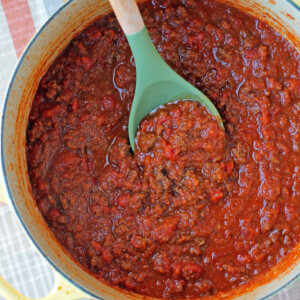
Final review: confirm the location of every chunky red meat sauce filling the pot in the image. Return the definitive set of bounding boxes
[26,0,300,298]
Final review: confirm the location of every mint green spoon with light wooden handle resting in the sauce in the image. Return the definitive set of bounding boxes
[109,0,224,150]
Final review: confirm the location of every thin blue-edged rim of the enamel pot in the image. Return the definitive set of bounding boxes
[0,0,300,300]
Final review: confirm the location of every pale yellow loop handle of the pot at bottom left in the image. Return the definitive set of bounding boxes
[0,270,91,300]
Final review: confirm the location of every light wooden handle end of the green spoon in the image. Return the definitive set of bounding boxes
[109,0,145,35]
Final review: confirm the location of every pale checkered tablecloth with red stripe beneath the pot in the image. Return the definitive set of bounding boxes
[0,0,300,300]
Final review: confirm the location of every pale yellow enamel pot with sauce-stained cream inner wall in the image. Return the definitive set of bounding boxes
[0,0,300,299]
